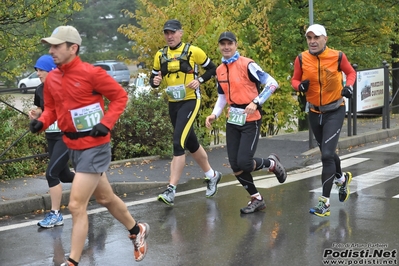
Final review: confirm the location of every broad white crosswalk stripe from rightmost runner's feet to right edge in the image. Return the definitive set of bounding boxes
[309,163,399,194]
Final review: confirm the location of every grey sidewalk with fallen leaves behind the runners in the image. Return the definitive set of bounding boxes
[0,115,399,217]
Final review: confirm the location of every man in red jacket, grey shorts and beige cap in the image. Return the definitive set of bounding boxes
[30,26,150,266]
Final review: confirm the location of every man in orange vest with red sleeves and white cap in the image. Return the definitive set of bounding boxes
[291,24,356,217]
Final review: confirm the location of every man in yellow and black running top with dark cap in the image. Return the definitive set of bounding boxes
[150,19,222,206]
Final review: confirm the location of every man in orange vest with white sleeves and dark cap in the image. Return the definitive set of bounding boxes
[205,31,287,214]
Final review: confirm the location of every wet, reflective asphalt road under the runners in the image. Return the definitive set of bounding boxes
[0,142,399,266]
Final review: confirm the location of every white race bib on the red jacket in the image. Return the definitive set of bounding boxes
[70,103,104,132]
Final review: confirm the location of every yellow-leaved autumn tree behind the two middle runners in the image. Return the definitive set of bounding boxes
[120,0,297,135]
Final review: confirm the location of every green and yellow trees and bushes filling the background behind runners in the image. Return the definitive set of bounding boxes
[0,0,399,178]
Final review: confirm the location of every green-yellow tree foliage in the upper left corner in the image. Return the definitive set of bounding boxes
[0,0,82,84]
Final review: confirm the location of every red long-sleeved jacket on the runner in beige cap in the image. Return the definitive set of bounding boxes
[38,56,128,150]
